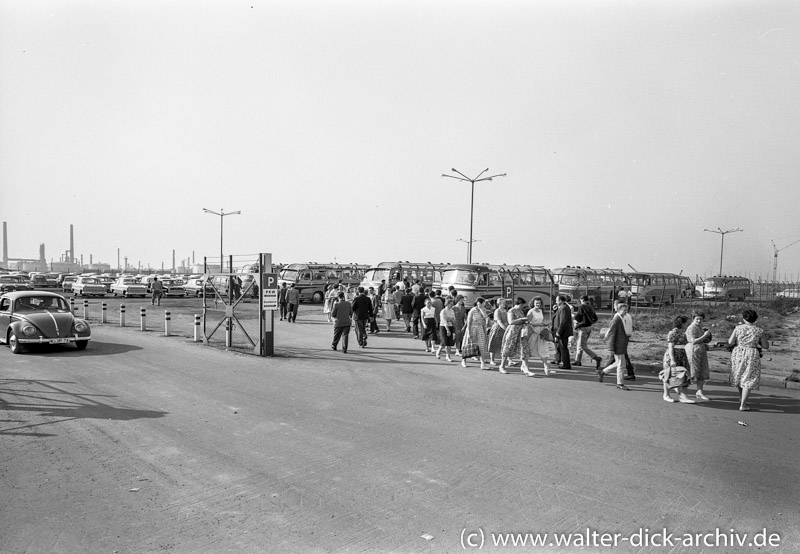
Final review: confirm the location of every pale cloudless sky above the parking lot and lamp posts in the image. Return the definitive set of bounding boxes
[0,0,800,280]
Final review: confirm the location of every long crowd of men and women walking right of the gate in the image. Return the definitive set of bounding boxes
[323,282,768,411]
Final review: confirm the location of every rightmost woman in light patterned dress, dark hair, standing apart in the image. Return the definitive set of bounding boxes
[728,309,769,412]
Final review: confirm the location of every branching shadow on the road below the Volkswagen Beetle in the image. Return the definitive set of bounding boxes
[0,379,169,437]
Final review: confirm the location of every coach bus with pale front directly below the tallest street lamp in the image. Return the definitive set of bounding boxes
[434,264,557,309]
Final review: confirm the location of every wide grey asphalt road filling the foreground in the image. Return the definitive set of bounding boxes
[0,305,800,553]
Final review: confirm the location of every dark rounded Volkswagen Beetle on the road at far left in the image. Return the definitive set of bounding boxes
[0,291,92,354]
